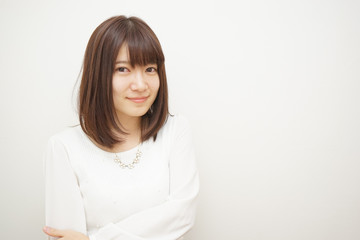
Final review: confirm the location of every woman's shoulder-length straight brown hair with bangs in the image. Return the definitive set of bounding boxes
[78,16,169,148]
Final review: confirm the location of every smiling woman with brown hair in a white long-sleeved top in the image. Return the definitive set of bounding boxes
[43,16,198,240]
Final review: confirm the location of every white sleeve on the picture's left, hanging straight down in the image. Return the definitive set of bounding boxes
[44,137,86,239]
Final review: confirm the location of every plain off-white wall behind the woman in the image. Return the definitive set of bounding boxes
[0,0,360,240]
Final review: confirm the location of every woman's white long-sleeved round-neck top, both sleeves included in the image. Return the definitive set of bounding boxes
[45,116,199,240]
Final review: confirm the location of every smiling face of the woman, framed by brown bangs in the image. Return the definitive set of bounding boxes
[112,44,160,121]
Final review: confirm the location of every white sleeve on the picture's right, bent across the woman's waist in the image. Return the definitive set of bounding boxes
[90,119,199,240]
